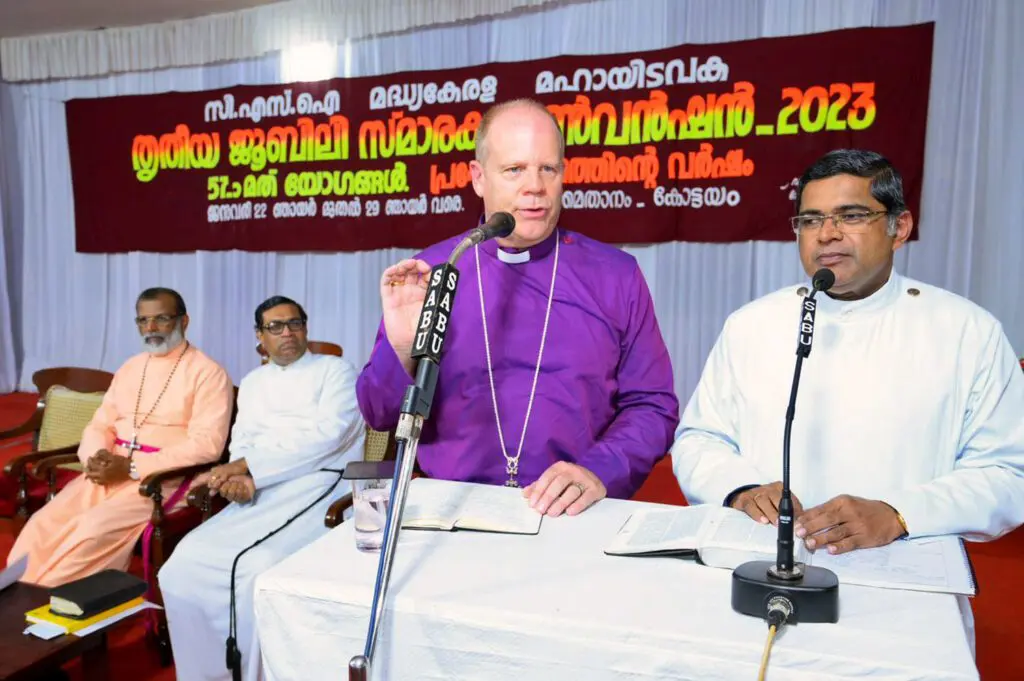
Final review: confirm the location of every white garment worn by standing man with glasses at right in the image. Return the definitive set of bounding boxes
[672,272,1024,539]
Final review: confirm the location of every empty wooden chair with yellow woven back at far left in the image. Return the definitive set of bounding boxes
[0,367,114,534]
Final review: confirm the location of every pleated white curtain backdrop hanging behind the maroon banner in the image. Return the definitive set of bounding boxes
[0,0,1024,403]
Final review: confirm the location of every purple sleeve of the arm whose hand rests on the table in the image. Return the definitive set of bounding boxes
[577,266,679,499]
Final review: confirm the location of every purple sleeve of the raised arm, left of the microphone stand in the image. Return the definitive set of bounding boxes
[355,321,413,430]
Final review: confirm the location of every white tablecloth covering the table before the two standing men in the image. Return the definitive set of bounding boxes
[255,493,978,681]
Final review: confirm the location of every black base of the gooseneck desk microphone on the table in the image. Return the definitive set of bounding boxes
[732,560,839,624]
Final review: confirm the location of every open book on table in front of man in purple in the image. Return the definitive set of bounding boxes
[401,477,544,535]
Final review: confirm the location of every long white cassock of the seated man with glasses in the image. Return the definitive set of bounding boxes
[159,352,365,681]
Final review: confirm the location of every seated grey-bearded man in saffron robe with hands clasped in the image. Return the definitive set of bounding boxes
[7,288,233,587]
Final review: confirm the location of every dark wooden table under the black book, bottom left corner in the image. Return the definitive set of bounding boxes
[0,582,110,681]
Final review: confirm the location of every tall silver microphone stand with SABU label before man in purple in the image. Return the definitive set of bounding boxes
[348,229,495,681]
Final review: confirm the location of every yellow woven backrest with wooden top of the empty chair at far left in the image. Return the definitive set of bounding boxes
[32,367,114,450]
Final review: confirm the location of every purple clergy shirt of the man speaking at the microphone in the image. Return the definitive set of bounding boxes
[356,228,679,498]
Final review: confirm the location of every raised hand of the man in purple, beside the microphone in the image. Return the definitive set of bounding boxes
[381,260,430,375]
